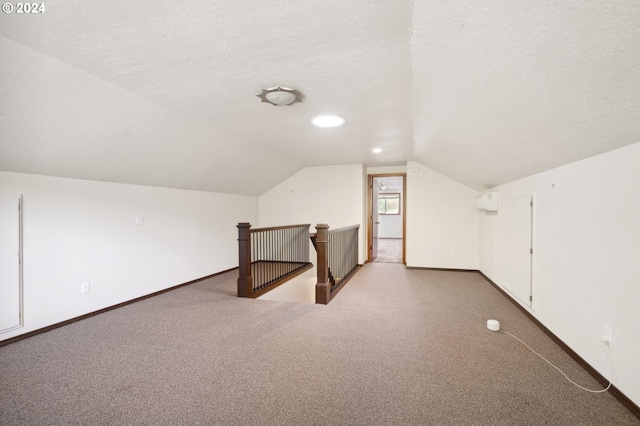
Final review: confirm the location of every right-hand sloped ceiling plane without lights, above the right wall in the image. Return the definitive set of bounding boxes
[412,0,640,188]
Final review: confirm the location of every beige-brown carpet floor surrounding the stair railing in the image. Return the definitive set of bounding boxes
[0,263,640,425]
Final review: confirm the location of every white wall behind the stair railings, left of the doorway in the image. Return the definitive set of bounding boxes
[252,164,367,263]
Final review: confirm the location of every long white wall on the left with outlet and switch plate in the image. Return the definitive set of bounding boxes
[0,172,258,340]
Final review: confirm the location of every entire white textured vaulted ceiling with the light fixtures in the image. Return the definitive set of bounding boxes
[0,0,640,195]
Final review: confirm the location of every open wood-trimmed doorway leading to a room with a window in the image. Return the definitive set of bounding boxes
[367,173,407,264]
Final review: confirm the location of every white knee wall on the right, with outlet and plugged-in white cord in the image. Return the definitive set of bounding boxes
[480,143,640,405]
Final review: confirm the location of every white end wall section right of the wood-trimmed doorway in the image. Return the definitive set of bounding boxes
[406,161,479,269]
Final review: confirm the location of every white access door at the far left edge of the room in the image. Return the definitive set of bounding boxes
[0,194,22,332]
